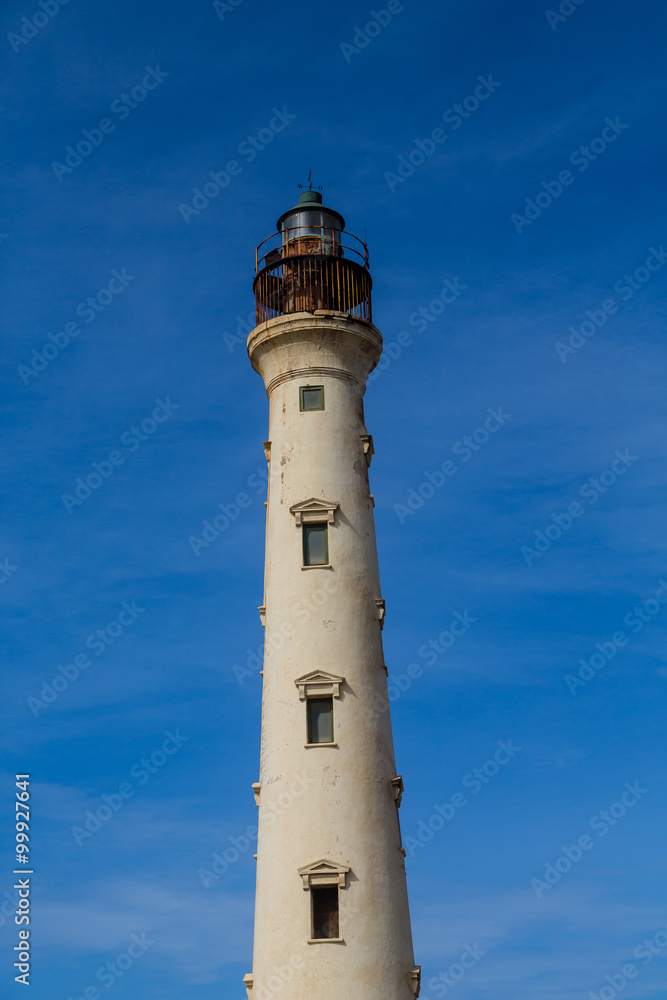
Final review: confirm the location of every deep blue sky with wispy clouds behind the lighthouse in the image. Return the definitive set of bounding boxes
[0,0,667,1000]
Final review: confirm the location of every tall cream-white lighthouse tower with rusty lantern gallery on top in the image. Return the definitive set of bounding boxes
[244,186,420,1000]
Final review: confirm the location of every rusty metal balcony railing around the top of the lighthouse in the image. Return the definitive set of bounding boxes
[253,226,373,324]
